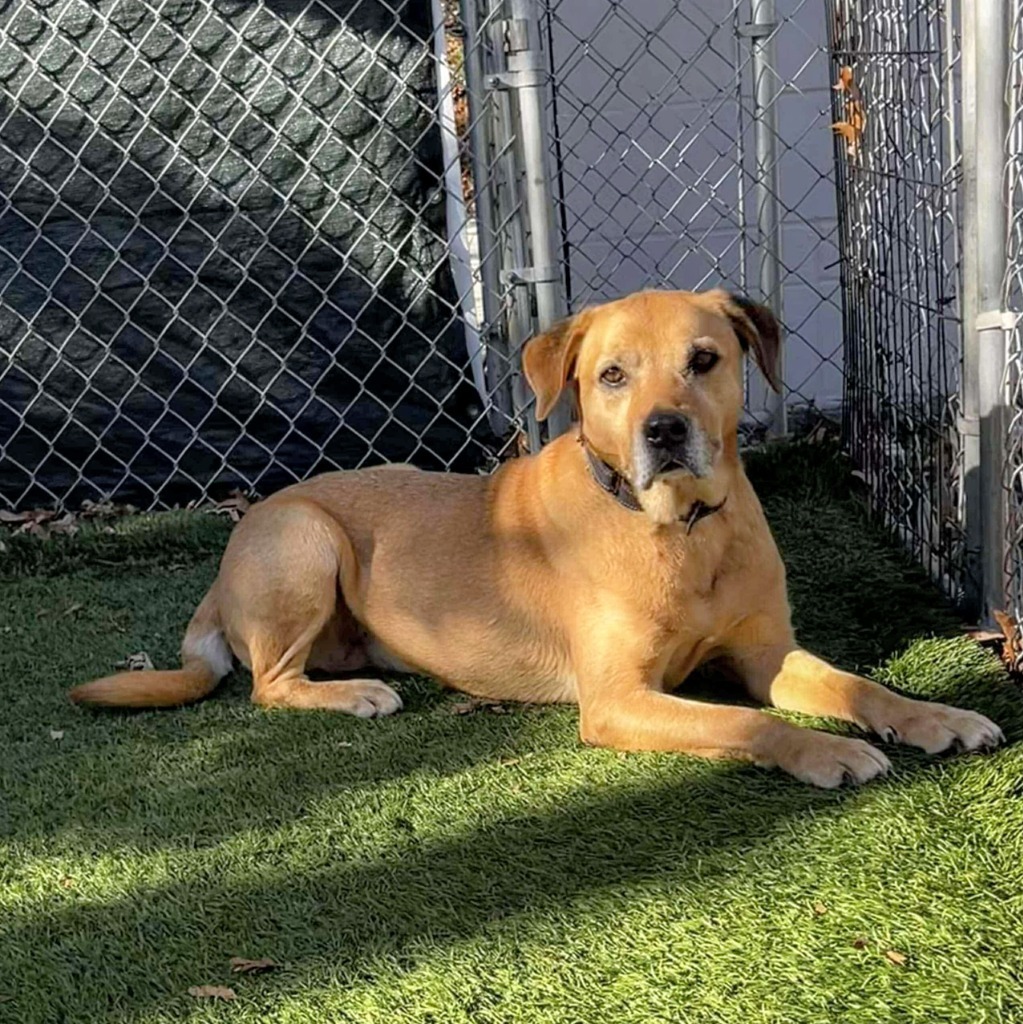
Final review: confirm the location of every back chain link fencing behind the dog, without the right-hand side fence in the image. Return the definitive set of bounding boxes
[0,0,842,507]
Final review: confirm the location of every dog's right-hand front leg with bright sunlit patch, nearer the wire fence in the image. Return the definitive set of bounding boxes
[729,641,1005,754]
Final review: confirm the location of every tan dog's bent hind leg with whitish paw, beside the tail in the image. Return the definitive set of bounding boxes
[217,499,401,718]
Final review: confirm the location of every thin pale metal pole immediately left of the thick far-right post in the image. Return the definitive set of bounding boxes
[948,0,984,622]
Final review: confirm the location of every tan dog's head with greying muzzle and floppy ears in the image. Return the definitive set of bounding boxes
[523,291,779,522]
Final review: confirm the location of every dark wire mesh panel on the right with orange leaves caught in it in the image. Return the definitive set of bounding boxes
[827,0,965,598]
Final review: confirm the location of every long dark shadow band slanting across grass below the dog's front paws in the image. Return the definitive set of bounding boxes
[0,745,925,1024]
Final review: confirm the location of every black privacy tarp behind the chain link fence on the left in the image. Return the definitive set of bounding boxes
[0,0,492,507]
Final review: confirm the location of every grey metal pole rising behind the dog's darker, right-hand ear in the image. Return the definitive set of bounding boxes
[747,0,787,437]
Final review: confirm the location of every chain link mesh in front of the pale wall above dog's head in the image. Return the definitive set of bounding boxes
[544,0,843,429]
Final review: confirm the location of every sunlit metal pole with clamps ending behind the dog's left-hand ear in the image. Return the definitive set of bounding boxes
[508,0,571,436]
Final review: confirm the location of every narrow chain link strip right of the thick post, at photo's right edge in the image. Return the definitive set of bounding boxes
[1005,0,1023,670]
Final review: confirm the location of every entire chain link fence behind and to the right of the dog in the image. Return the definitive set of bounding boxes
[0,0,1023,643]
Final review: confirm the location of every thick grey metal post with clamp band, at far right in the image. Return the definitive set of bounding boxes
[964,0,1009,622]
